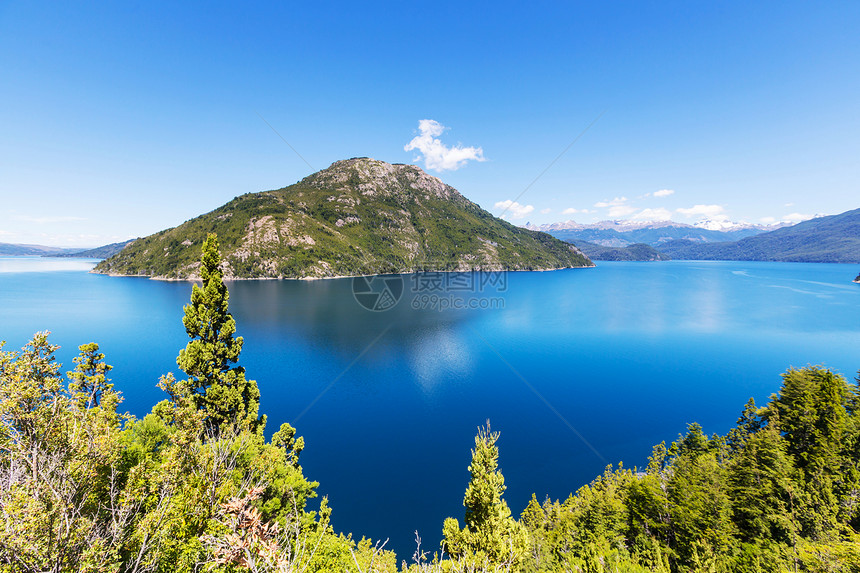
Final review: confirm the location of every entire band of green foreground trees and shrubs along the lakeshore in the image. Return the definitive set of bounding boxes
[0,237,860,573]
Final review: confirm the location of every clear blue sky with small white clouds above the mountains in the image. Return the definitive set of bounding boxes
[0,1,860,246]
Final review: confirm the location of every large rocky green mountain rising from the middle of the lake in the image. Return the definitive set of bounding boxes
[95,158,592,279]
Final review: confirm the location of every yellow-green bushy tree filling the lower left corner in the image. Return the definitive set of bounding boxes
[0,332,129,573]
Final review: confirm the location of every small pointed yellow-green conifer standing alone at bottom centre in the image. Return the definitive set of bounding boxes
[442,420,526,565]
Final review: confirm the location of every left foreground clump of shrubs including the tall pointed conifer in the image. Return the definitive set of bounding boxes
[0,237,394,573]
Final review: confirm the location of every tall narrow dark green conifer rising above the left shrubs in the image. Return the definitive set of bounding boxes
[176,233,265,429]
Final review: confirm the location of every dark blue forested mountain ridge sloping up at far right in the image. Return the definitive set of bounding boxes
[660,209,860,263]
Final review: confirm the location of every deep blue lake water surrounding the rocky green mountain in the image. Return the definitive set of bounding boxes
[0,258,860,559]
